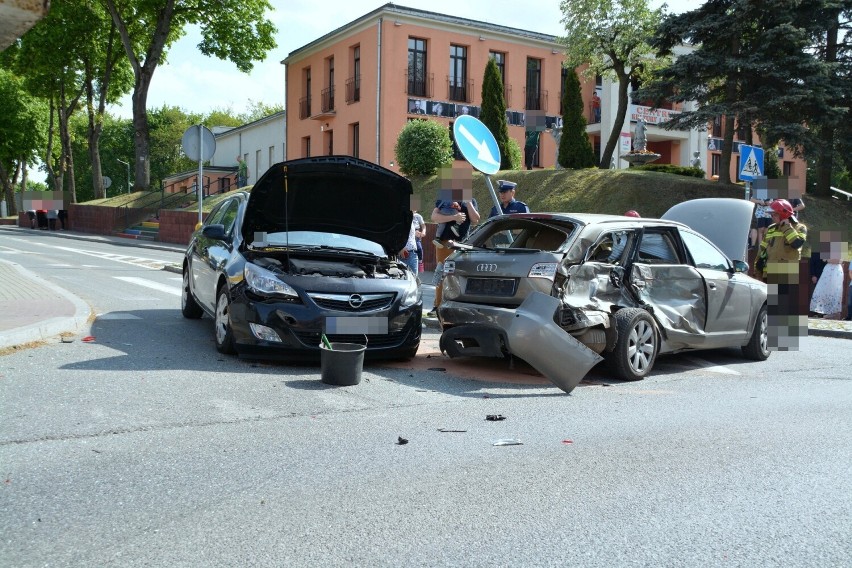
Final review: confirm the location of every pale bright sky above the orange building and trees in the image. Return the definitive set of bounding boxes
[109,0,703,118]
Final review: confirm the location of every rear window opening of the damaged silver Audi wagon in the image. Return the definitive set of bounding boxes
[466,218,575,251]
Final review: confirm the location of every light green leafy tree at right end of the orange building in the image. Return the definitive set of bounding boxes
[560,0,667,168]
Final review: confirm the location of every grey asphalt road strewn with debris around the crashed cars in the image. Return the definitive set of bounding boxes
[0,232,852,567]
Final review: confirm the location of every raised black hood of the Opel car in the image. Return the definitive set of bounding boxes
[242,156,413,255]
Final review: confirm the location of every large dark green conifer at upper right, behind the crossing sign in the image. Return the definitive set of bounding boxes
[639,0,842,189]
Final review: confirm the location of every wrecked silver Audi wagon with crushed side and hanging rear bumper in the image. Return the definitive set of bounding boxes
[438,199,769,392]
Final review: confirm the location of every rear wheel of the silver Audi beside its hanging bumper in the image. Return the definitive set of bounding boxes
[607,308,660,381]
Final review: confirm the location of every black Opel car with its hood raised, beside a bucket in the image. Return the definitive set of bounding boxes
[181,156,423,359]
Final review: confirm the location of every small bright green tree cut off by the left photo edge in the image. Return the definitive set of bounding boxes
[0,68,48,214]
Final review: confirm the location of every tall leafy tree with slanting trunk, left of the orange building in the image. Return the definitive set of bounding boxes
[104,0,277,189]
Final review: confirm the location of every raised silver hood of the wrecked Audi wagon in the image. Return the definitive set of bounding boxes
[662,197,754,260]
